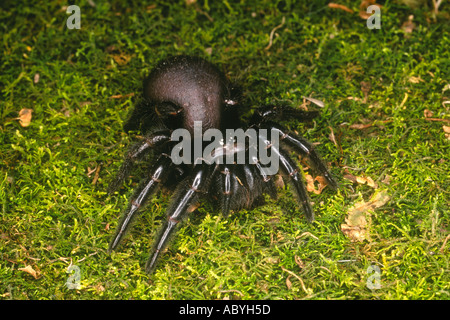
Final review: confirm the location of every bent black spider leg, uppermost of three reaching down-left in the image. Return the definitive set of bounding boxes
[108,130,170,194]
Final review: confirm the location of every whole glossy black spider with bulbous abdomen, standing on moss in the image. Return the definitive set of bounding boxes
[109,56,337,273]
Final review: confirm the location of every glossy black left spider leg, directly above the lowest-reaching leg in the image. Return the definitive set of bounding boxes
[108,154,172,252]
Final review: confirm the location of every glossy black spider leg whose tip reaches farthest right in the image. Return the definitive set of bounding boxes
[267,123,338,190]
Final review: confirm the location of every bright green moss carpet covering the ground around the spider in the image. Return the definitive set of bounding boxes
[0,1,450,299]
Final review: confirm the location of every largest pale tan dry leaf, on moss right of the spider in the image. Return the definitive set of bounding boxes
[341,190,390,242]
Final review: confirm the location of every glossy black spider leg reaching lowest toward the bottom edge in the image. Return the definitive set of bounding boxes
[145,165,212,273]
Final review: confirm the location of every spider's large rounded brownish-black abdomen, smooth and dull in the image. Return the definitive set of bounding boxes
[144,56,228,134]
